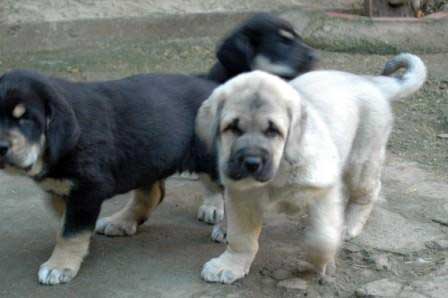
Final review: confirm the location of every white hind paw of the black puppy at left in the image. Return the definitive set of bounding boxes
[95,216,137,237]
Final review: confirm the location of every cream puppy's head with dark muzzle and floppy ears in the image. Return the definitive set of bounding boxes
[196,71,301,189]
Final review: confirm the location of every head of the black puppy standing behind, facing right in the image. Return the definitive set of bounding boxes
[217,13,316,79]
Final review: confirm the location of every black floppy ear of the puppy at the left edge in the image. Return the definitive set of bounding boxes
[43,86,81,164]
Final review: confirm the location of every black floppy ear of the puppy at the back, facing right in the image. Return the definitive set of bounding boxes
[216,32,255,76]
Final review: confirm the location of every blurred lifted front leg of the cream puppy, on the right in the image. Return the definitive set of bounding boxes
[305,185,343,276]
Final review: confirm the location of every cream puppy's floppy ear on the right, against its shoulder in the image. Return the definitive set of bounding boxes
[284,90,307,163]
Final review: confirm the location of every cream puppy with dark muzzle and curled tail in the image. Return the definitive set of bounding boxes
[196,54,426,283]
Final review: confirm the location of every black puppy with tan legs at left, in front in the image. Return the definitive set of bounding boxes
[0,12,316,284]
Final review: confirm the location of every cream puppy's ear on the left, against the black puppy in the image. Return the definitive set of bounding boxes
[196,87,225,150]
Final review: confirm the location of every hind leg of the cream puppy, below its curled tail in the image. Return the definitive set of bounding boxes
[344,147,386,240]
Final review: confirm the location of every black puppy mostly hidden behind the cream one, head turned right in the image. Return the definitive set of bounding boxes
[197,13,316,224]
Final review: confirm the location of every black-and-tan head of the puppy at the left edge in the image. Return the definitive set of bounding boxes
[0,70,79,176]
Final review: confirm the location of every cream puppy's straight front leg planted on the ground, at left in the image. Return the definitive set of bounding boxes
[201,191,263,284]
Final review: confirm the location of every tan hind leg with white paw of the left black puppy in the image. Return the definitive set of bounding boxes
[96,181,165,236]
